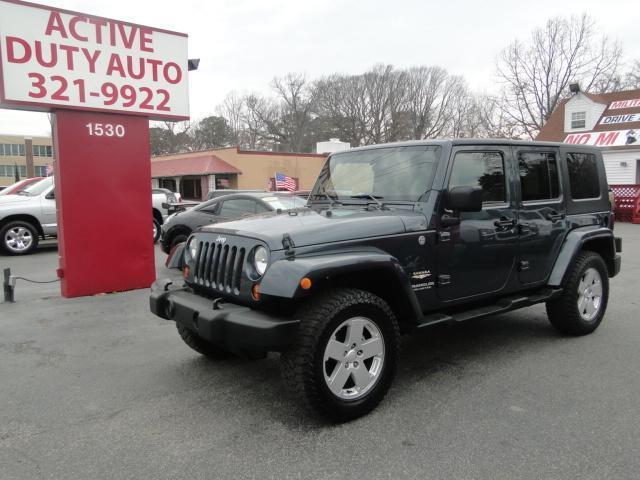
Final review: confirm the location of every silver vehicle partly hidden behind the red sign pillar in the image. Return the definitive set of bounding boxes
[0,177,168,255]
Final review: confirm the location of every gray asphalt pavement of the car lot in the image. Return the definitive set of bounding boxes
[0,223,640,480]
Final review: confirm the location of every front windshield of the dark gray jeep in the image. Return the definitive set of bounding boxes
[312,145,442,202]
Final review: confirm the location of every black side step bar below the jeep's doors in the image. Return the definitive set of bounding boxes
[416,288,562,328]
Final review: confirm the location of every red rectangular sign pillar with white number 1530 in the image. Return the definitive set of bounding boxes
[54,110,155,297]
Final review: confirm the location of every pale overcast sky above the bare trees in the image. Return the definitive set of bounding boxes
[0,0,640,135]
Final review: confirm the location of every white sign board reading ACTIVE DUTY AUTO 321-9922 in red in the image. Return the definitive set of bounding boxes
[0,0,189,120]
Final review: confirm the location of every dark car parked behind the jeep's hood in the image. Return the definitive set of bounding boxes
[160,192,306,253]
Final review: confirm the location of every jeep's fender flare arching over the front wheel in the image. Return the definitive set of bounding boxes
[260,249,422,318]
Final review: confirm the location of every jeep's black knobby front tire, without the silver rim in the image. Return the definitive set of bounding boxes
[281,288,400,422]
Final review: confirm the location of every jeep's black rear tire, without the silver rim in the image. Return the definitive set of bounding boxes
[547,250,609,336]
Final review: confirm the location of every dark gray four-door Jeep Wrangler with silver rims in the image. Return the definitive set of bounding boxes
[150,140,621,421]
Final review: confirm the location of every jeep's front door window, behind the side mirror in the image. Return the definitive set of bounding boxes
[449,152,506,202]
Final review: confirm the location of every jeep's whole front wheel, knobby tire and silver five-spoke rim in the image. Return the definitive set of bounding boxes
[281,289,400,422]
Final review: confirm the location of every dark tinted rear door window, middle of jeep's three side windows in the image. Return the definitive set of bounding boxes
[518,152,559,201]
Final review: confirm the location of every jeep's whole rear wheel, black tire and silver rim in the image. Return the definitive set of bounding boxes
[547,251,609,335]
